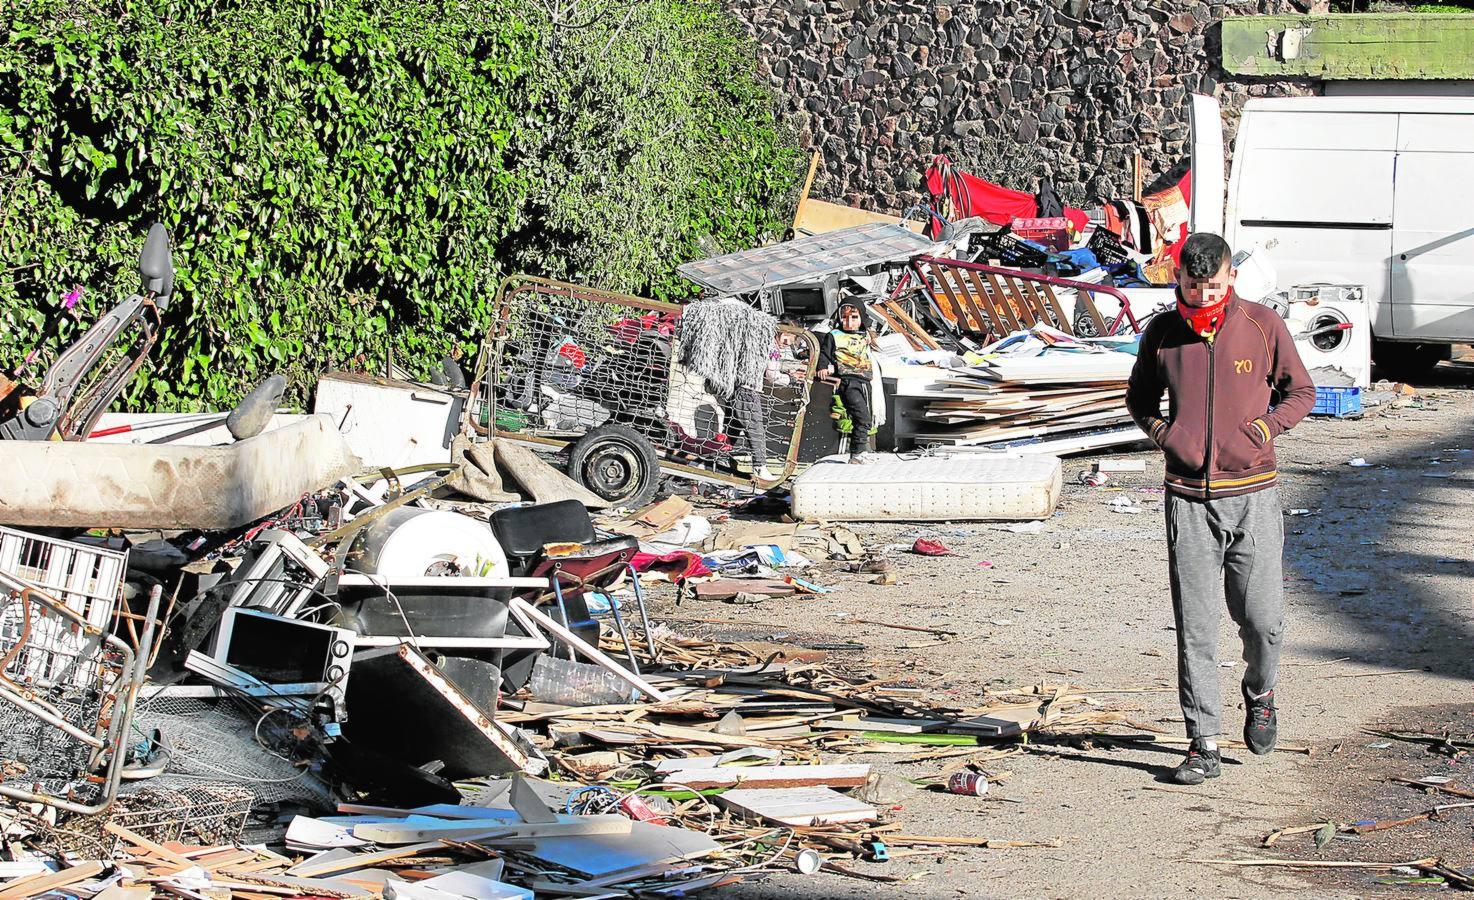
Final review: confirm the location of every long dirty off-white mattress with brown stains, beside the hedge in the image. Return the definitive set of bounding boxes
[0,415,361,530]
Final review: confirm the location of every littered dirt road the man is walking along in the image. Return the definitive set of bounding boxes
[662,365,1474,897]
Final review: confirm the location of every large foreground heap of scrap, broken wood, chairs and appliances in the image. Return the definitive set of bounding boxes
[0,471,1149,900]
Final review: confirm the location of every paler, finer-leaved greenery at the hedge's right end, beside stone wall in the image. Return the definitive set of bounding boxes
[509,0,803,299]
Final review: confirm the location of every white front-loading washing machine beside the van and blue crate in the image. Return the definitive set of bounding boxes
[1263,284,1372,387]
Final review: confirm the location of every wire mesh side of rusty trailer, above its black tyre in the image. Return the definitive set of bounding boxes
[469,278,817,480]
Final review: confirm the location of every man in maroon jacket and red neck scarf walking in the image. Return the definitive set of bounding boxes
[1126,233,1315,785]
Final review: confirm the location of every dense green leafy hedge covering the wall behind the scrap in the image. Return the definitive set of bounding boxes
[0,0,799,409]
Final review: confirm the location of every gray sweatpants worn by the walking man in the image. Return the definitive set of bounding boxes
[1166,488,1284,738]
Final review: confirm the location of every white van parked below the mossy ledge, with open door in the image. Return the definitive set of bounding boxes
[1192,96,1474,374]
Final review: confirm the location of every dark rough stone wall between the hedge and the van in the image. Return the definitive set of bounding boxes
[727,0,1319,212]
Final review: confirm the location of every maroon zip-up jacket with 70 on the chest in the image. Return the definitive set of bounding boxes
[1126,296,1315,499]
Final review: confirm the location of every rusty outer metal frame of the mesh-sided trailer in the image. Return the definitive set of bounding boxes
[461,275,818,488]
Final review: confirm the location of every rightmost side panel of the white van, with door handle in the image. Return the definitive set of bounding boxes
[1391,112,1474,342]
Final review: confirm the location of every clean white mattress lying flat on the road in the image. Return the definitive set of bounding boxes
[793,455,1063,521]
